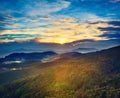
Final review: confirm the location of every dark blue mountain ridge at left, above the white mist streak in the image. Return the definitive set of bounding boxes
[0,51,56,63]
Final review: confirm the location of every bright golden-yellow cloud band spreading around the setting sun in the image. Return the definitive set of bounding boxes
[0,18,114,43]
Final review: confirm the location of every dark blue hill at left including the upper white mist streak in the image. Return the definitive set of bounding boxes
[0,51,57,70]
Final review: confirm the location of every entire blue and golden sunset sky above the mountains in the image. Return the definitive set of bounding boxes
[0,0,120,55]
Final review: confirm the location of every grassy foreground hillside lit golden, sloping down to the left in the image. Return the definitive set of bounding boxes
[0,46,120,98]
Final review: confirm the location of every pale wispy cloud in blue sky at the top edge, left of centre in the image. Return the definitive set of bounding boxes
[26,0,70,16]
